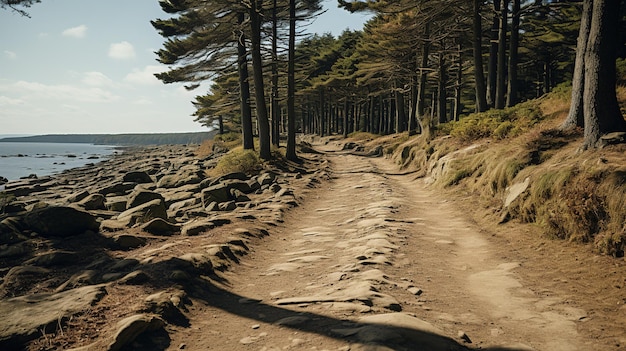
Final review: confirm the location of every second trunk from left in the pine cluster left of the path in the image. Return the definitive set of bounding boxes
[250,0,272,160]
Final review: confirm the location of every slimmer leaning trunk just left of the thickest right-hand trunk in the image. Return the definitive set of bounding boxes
[559,1,593,130]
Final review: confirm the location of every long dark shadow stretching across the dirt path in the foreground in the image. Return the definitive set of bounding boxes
[172,278,528,351]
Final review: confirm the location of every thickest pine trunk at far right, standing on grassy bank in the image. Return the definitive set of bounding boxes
[583,0,626,149]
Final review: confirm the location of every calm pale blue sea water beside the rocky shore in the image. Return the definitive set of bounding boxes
[0,142,115,180]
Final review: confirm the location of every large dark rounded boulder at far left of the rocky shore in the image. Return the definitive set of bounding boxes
[24,206,100,237]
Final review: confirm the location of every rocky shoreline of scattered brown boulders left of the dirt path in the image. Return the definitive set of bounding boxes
[0,145,328,350]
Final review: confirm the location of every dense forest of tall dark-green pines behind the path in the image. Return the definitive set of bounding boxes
[153,0,626,159]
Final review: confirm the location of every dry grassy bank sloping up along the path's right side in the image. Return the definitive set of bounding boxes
[346,94,626,257]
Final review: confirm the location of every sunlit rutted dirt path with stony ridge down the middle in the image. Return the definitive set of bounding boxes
[169,144,623,351]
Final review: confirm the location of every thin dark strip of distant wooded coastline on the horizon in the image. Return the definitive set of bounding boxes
[0,130,217,145]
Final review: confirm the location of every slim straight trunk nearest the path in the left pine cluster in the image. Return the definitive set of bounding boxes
[285,0,304,161]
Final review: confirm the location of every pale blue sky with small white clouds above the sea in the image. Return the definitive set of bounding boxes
[0,0,368,134]
